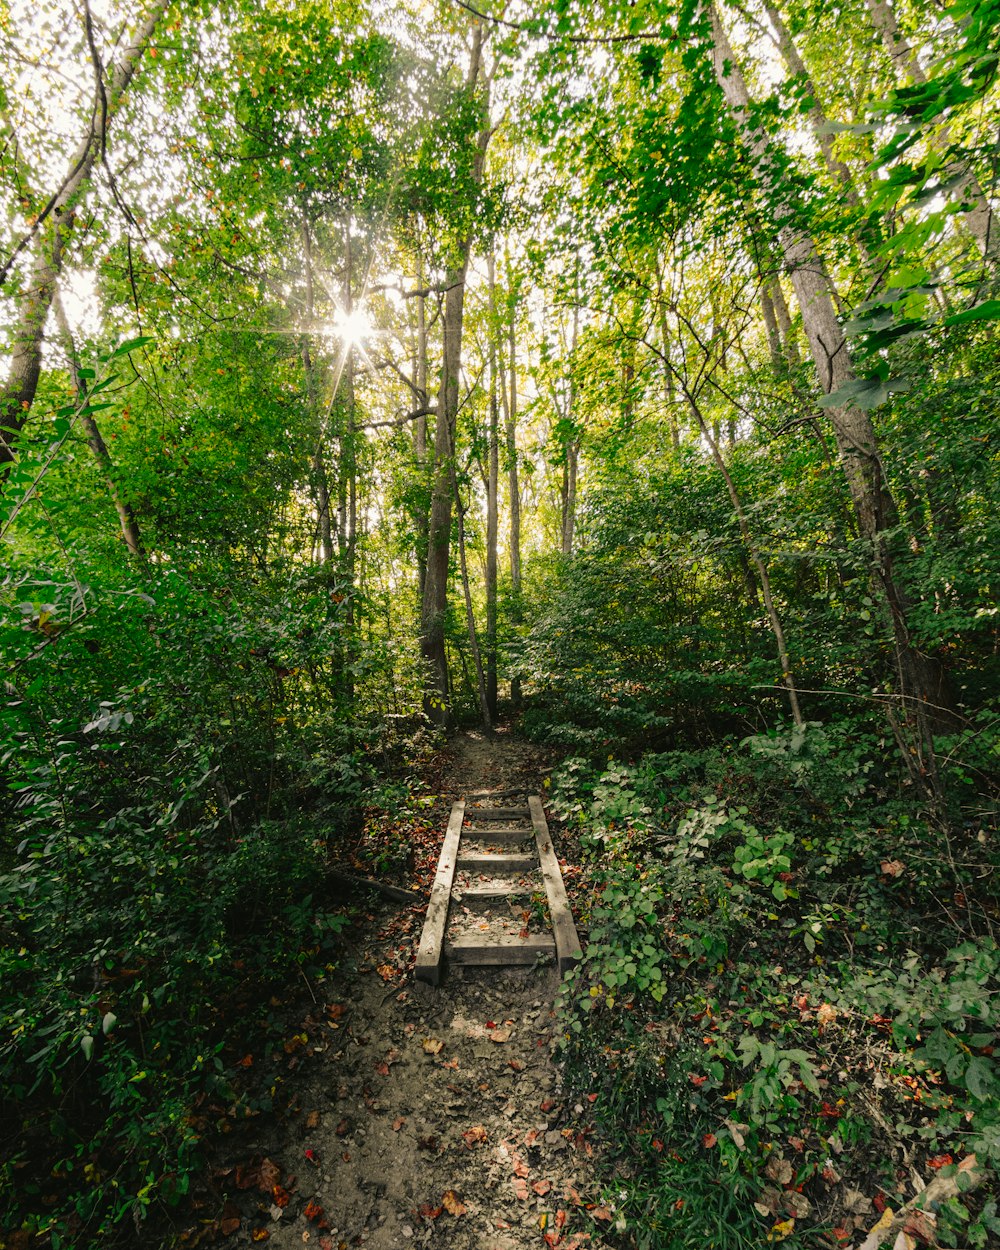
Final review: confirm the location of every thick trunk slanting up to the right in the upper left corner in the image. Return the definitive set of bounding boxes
[0,0,169,475]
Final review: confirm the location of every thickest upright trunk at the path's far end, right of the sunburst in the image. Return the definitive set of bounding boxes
[420,21,490,724]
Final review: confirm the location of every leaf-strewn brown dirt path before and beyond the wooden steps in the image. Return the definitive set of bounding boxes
[220,735,611,1250]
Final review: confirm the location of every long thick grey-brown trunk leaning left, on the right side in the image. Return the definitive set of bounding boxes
[710,6,946,785]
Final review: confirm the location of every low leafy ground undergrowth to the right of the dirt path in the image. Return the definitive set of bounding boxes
[551,723,1000,1250]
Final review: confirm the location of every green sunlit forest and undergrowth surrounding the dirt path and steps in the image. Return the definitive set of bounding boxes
[0,0,1000,1250]
